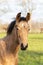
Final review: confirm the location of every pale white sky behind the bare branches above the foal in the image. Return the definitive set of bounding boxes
[0,0,43,23]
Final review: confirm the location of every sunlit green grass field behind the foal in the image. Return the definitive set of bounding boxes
[0,33,43,65]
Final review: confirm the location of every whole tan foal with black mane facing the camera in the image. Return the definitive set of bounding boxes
[0,13,30,65]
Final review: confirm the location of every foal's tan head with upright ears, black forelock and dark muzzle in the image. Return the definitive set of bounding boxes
[16,13,30,50]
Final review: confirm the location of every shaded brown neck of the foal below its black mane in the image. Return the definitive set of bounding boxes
[4,28,19,54]
